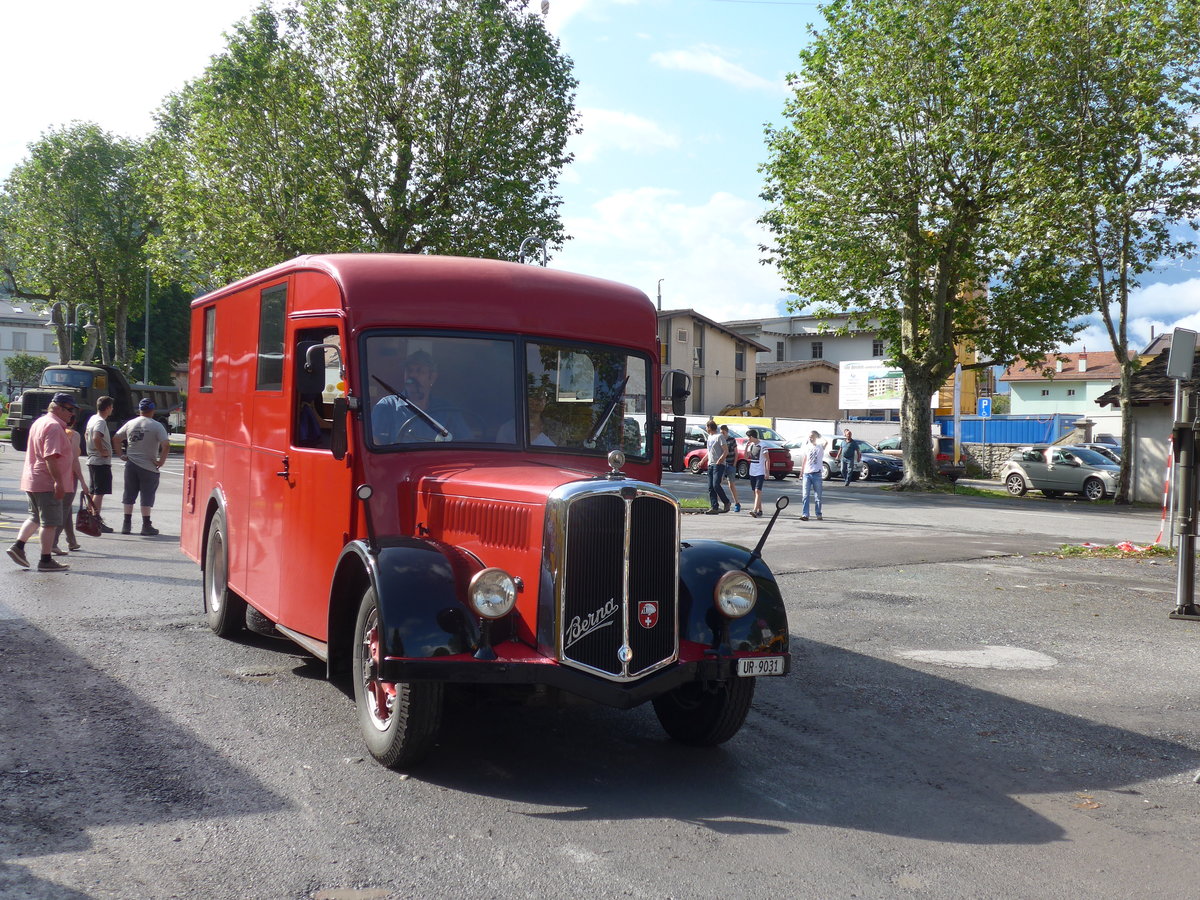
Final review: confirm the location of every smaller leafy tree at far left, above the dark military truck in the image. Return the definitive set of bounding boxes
[0,122,152,365]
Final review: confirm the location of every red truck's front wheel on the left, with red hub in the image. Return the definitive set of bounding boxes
[353,588,443,768]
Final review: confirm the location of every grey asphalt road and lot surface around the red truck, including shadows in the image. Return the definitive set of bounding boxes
[0,448,1200,900]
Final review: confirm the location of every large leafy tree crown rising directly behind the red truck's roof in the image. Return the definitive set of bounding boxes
[151,0,577,284]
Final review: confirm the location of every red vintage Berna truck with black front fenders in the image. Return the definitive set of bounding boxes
[180,254,791,767]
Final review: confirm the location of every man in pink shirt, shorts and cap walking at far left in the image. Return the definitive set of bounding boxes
[8,392,77,572]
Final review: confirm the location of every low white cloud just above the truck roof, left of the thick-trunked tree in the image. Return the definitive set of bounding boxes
[554,187,782,322]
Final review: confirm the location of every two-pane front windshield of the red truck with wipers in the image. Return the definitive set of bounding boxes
[362,332,650,457]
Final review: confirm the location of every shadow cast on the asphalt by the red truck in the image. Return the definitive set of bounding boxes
[414,641,1200,845]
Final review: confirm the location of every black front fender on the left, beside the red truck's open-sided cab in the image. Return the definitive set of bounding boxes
[343,538,480,659]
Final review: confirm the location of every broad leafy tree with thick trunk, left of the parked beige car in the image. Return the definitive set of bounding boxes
[763,0,1087,487]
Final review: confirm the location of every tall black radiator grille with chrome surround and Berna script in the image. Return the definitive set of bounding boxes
[539,479,679,682]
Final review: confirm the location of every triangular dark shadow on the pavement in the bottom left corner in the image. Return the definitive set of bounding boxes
[0,618,287,898]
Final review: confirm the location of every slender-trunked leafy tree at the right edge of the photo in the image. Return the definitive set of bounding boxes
[1031,0,1200,504]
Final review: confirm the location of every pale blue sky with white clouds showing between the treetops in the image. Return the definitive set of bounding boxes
[0,0,1200,349]
